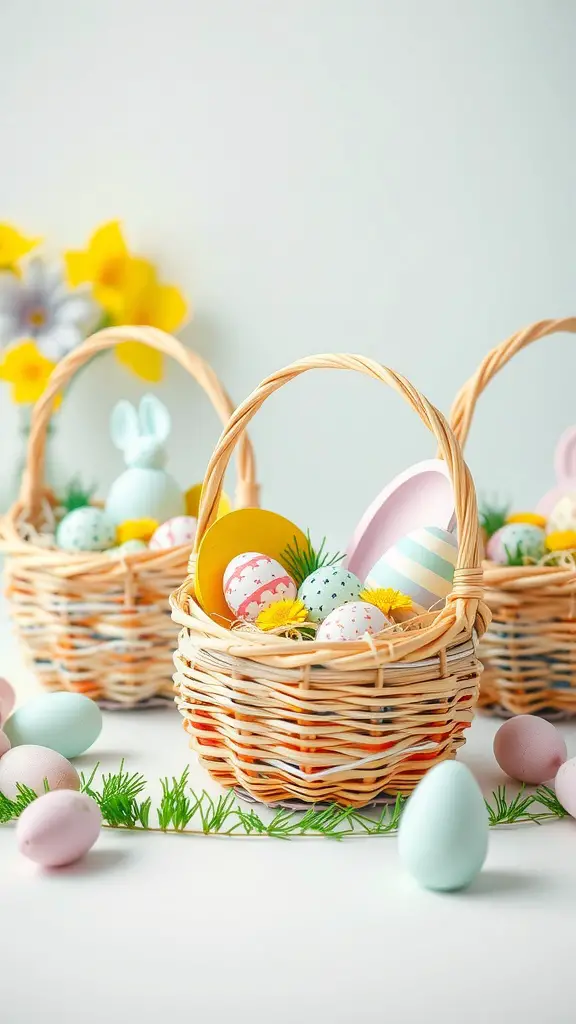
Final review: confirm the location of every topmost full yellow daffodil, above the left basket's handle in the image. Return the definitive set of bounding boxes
[65,220,154,324]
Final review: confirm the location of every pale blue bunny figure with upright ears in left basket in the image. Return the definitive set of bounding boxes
[106,394,186,526]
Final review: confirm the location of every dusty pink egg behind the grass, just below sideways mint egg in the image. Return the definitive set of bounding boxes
[0,745,80,800]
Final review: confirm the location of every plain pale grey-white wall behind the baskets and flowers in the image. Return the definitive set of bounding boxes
[0,0,576,544]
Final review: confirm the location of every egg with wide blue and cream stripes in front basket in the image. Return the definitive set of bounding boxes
[367,526,458,610]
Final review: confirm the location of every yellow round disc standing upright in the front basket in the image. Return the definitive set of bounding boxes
[195,509,307,626]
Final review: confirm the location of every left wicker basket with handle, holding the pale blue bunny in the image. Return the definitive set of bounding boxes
[1,328,257,707]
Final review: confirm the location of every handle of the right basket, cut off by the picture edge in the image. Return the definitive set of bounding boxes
[450,316,576,447]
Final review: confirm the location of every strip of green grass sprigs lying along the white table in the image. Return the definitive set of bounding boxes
[0,761,567,841]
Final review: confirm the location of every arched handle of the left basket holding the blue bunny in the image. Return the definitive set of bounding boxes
[16,327,259,522]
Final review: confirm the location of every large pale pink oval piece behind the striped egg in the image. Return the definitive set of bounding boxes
[345,459,456,582]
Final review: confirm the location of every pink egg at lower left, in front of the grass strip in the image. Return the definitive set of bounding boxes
[16,790,101,867]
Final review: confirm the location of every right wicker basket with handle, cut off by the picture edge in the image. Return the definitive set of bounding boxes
[451,317,576,716]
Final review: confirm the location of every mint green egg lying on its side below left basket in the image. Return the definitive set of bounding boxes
[4,692,102,758]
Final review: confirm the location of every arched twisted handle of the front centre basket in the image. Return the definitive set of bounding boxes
[195,354,482,585]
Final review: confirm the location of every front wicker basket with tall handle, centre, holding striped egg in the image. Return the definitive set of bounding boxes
[171,355,489,806]
